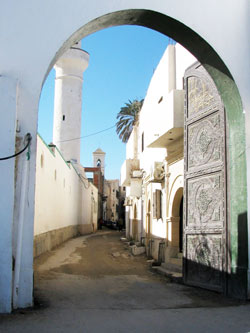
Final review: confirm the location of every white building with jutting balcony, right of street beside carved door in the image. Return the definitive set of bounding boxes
[121,44,196,269]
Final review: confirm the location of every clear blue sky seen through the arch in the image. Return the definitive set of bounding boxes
[38,26,168,179]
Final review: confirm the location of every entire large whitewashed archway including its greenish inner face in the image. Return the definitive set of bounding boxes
[0,0,249,312]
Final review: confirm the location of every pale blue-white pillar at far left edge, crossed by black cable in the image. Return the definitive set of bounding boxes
[0,76,17,313]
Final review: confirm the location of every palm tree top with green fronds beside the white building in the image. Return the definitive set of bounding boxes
[116,99,144,143]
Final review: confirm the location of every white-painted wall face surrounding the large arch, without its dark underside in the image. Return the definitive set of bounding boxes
[0,0,250,312]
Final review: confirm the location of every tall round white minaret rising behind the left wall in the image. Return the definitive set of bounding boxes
[53,42,89,163]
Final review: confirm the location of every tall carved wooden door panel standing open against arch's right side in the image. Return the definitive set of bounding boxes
[183,63,227,291]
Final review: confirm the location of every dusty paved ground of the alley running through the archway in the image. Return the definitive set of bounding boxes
[0,230,250,333]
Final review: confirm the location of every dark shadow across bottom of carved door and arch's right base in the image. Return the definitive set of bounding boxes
[183,212,248,300]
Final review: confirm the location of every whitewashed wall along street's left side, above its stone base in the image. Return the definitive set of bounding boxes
[34,136,98,236]
